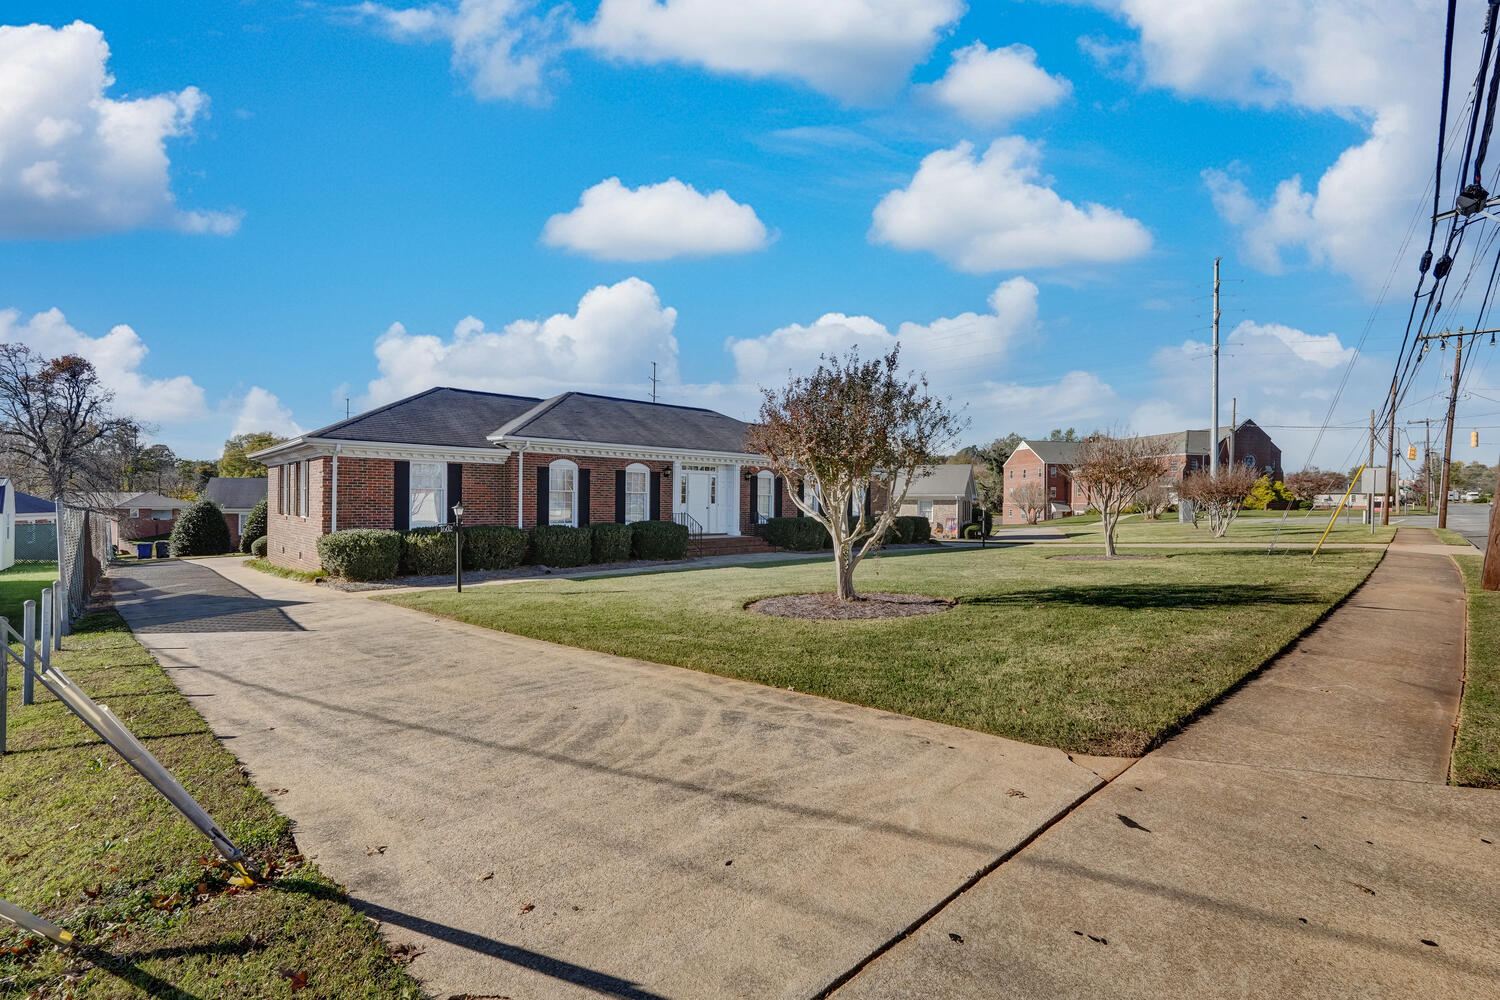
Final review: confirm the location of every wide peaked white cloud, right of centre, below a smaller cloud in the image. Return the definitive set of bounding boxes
[870,136,1151,273]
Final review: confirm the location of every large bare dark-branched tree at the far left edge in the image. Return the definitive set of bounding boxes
[0,343,140,502]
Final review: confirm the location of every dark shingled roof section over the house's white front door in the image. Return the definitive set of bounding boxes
[497,393,750,453]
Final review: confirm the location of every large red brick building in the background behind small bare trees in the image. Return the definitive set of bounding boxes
[1001,420,1284,525]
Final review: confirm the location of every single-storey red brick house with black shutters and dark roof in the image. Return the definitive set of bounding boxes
[252,387,834,570]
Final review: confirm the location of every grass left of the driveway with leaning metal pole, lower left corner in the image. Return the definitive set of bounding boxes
[0,612,422,1000]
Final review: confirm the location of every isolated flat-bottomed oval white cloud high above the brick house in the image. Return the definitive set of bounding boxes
[542,177,768,261]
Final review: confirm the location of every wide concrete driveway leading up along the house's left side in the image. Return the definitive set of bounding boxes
[111,559,1101,1000]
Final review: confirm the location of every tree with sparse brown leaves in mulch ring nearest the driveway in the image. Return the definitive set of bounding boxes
[746,346,968,601]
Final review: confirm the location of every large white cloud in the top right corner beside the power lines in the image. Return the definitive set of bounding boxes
[1095,0,1452,292]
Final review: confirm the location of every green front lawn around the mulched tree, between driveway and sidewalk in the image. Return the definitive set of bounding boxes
[381,546,1380,756]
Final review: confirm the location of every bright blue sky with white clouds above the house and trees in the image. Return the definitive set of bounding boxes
[0,0,1500,468]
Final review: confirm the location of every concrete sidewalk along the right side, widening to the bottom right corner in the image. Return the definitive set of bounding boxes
[834,531,1500,1000]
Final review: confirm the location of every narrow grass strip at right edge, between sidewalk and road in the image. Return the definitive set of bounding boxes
[1452,556,1500,789]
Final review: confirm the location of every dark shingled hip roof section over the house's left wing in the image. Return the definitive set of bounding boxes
[305,387,542,448]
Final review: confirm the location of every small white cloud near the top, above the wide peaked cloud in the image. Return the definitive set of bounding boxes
[929,42,1073,126]
